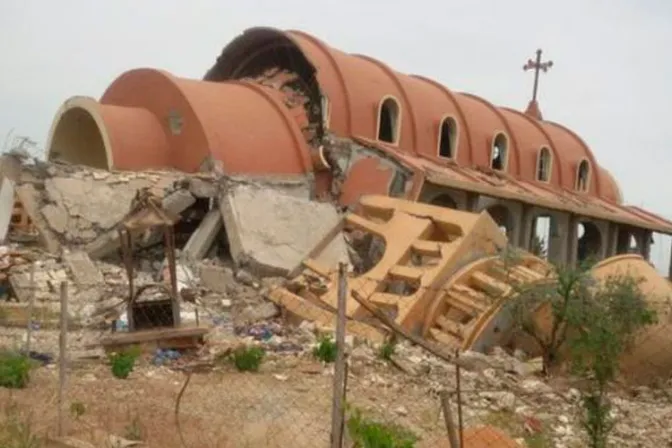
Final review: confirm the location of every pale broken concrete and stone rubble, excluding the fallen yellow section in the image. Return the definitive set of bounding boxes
[0,156,672,448]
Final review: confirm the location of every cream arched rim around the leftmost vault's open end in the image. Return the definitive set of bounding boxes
[47,96,114,170]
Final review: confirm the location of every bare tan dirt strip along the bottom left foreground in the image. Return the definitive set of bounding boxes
[0,356,452,448]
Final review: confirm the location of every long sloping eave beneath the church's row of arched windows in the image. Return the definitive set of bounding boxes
[354,136,672,235]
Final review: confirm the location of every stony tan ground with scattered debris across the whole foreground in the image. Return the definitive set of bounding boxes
[0,290,672,448]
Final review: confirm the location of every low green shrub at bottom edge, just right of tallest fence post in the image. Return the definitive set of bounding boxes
[348,409,418,448]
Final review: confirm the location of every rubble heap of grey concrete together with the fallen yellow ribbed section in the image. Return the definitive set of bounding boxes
[0,154,672,446]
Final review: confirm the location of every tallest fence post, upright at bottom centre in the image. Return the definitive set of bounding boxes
[331,263,348,448]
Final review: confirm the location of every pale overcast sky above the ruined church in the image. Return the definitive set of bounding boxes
[0,0,672,270]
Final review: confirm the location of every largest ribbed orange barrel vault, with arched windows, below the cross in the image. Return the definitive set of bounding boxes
[205,28,619,201]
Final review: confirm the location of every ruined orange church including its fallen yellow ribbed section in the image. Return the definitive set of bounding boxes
[40,28,672,382]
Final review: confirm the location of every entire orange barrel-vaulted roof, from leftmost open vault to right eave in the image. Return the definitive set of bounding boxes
[48,28,672,233]
